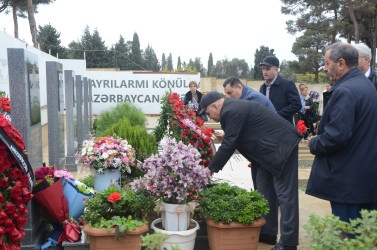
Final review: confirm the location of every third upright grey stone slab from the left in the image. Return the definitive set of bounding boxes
[64,70,77,171]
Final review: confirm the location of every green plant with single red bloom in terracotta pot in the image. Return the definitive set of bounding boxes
[82,186,155,250]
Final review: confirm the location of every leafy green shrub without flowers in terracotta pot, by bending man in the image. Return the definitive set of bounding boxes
[199,183,269,250]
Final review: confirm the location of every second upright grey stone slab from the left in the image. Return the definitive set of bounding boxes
[46,62,65,169]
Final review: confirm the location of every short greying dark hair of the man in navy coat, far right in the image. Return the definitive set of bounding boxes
[326,42,359,68]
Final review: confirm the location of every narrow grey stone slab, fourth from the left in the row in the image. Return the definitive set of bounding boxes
[75,75,84,148]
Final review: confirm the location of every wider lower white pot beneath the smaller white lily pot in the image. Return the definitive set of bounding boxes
[151,219,199,250]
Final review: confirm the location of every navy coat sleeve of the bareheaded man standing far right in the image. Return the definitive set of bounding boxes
[310,89,356,155]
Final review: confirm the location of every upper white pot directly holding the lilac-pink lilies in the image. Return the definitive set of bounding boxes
[160,202,191,231]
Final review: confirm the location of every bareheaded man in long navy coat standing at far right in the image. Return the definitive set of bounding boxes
[306,43,377,221]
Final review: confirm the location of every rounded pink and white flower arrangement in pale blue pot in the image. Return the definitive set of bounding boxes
[77,134,135,191]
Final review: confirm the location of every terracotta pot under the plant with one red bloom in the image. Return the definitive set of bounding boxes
[84,224,148,250]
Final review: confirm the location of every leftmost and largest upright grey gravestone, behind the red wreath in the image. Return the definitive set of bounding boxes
[7,48,47,249]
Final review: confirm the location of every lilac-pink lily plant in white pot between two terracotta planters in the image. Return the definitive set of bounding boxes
[130,139,210,248]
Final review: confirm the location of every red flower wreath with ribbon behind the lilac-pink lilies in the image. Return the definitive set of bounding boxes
[156,93,216,166]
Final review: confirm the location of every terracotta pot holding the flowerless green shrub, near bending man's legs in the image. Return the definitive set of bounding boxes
[206,218,266,250]
